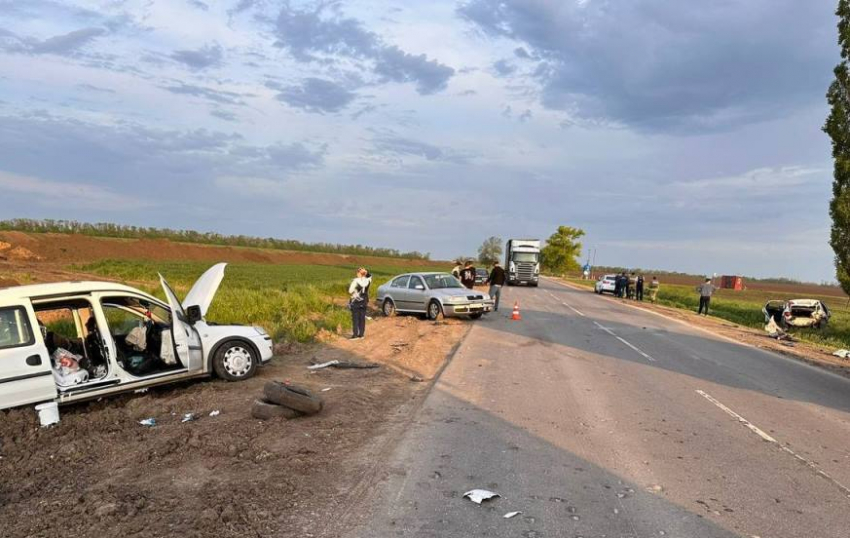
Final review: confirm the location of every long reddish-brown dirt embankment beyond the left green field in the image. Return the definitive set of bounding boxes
[0,232,445,267]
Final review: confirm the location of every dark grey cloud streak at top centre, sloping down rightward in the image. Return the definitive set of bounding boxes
[275,2,455,95]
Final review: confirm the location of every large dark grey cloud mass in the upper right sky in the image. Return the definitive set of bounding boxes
[459,0,838,133]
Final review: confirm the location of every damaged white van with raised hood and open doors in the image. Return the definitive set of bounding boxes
[0,263,272,409]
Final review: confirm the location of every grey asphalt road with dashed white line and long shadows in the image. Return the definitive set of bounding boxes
[345,282,850,538]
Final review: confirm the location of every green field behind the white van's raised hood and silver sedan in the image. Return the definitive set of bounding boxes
[73,261,434,342]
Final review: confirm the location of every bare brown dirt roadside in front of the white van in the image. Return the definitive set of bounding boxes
[0,316,464,538]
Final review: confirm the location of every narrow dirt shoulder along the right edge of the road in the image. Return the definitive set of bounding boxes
[556,279,850,377]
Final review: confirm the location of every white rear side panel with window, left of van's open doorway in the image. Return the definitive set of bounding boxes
[0,304,56,409]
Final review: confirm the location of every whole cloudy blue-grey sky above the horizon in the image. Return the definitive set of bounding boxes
[0,0,840,281]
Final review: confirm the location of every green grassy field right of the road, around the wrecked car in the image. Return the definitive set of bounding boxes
[567,278,850,348]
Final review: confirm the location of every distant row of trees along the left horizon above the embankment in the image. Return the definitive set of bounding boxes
[0,219,431,260]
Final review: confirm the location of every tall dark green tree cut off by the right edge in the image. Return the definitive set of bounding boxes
[823,0,850,294]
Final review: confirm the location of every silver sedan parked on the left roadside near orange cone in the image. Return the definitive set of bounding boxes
[376,273,495,320]
